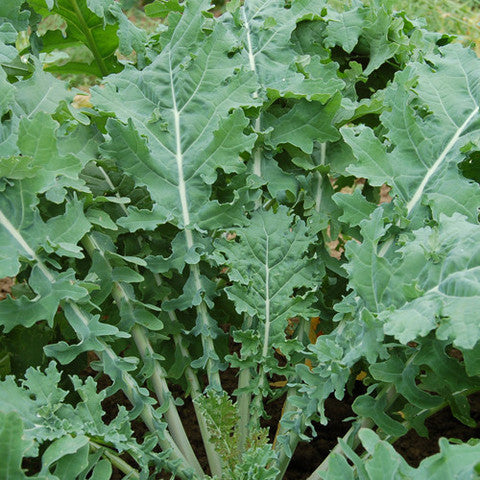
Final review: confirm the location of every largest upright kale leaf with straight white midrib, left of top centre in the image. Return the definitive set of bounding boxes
[92,0,258,234]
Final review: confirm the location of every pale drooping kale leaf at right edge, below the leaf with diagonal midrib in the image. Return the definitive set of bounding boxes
[381,215,480,349]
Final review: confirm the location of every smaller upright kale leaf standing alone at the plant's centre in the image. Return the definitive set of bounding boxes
[216,207,323,370]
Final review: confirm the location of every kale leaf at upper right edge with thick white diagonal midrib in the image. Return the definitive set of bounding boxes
[342,45,480,226]
